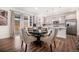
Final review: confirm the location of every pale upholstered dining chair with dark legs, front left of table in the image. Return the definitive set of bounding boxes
[21,29,36,52]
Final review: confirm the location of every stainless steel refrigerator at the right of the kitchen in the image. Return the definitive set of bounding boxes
[65,19,77,35]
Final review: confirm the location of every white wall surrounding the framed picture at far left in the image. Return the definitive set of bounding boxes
[0,7,10,39]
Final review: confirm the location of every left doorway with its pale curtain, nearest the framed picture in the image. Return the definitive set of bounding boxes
[10,10,21,39]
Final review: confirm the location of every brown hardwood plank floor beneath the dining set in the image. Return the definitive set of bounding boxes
[0,35,77,52]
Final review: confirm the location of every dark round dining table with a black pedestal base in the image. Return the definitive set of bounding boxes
[29,30,47,47]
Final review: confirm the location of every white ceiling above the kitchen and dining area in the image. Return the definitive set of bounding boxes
[16,7,77,16]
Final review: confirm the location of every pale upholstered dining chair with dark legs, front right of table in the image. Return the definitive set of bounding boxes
[41,29,57,52]
